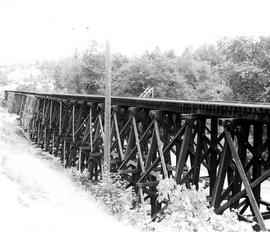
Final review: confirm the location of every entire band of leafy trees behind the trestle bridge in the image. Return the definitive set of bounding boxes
[0,37,270,102]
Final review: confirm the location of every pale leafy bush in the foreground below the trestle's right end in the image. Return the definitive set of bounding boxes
[155,179,253,232]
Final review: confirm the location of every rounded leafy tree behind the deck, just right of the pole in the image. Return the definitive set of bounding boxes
[113,48,193,98]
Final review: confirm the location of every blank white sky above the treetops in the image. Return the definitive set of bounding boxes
[0,0,270,64]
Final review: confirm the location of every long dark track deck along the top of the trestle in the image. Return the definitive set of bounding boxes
[5,90,270,122]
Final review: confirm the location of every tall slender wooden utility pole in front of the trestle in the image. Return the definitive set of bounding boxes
[104,40,111,182]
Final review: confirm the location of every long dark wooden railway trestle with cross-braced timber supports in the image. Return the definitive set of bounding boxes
[5,91,270,230]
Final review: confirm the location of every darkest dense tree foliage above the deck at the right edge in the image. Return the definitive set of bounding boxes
[218,37,270,102]
